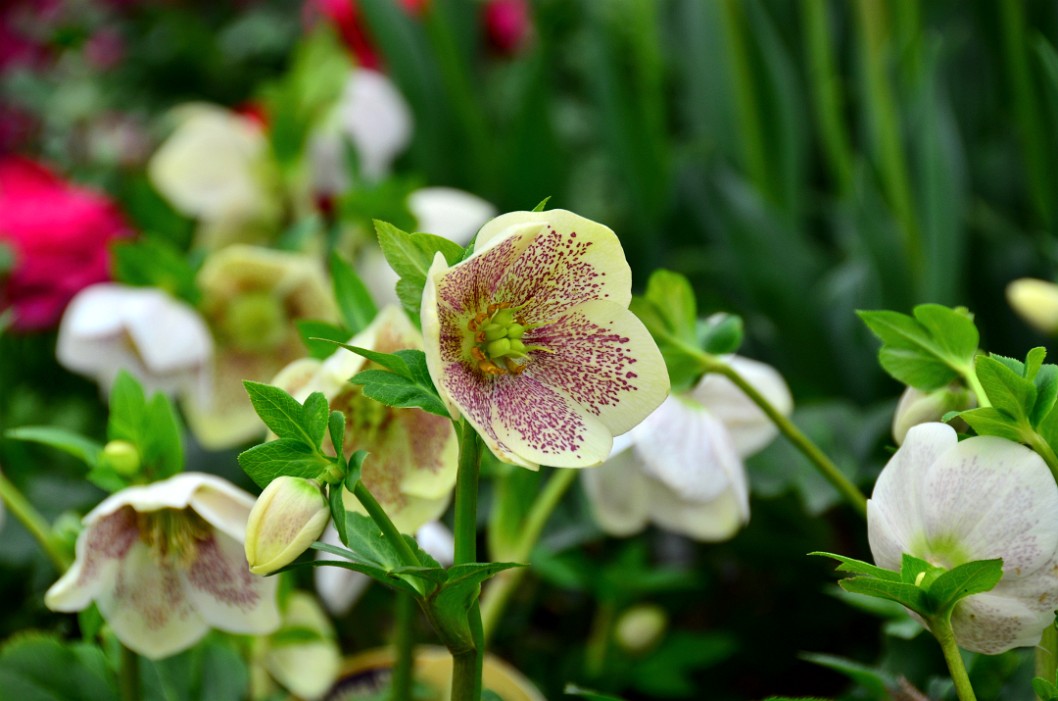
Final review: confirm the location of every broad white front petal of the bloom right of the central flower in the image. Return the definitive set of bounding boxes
[633,396,748,511]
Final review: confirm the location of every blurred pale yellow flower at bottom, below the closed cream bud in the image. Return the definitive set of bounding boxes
[251,591,342,701]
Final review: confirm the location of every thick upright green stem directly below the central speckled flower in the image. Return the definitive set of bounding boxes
[452,419,485,701]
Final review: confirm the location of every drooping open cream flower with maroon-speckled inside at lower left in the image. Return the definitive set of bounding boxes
[44,473,279,660]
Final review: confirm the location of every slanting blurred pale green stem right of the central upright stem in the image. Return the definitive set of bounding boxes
[481,469,577,641]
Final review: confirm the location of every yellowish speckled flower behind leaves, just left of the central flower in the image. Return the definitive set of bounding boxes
[272,307,459,533]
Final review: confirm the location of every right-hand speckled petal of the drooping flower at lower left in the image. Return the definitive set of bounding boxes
[182,532,279,634]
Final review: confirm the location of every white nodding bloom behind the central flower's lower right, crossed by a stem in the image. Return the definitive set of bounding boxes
[582,355,794,541]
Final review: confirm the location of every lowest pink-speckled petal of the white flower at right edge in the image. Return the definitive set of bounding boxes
[951,592,1054,654]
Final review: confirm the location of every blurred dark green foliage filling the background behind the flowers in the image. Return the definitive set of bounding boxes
[0,0,1058,700]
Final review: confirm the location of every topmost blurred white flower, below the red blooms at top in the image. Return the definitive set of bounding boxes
[309,69,412,195]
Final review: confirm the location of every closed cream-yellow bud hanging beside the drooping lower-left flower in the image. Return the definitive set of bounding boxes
[247,476,330,575]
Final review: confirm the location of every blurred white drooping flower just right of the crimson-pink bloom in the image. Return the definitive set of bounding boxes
[55,282,213,402]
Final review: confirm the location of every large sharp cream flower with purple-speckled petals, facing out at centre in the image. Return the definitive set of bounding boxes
[422,209,669,468]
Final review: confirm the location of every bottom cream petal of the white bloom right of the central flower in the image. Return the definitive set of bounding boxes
[649,475,749,542]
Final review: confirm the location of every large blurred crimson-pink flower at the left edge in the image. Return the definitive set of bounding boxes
[0,156,131,331]
